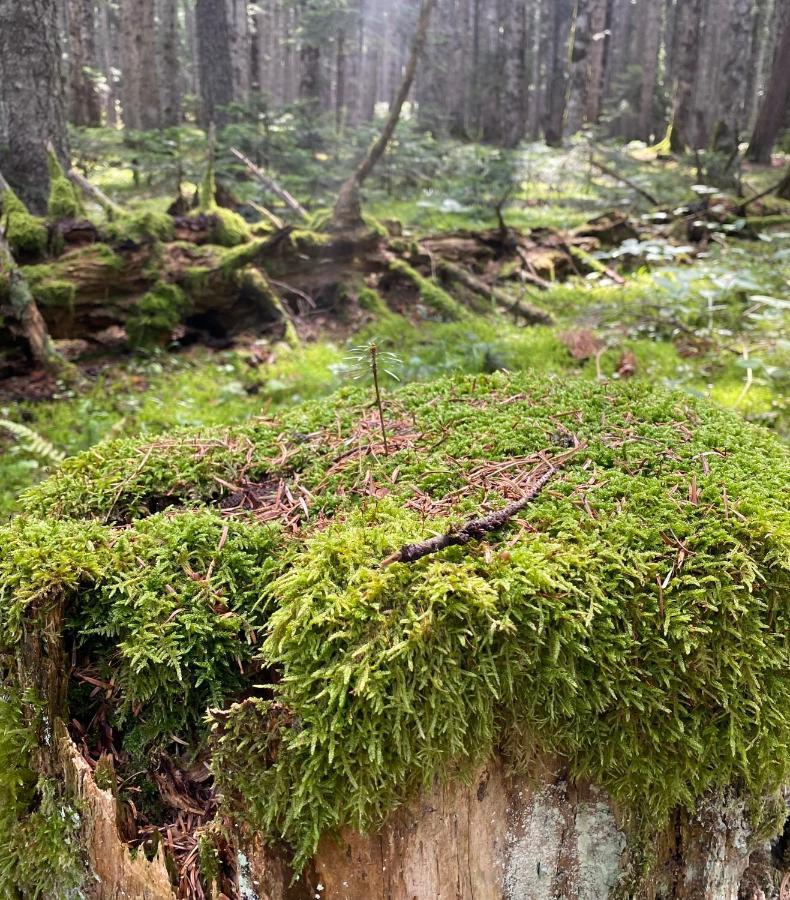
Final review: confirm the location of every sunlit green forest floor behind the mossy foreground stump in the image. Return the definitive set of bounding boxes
[0,129,790,518]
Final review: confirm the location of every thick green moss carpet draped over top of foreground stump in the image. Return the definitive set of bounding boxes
[0,374,790,862]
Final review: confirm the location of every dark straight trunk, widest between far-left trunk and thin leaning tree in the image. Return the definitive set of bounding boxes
[195,0,233,128]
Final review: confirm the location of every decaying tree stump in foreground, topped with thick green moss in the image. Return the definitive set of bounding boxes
[0,374,790,900]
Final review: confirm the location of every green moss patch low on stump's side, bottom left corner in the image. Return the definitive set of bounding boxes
[0,683,84,900]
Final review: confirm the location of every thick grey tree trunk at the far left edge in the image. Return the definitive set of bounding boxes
[0,0,67,213]
